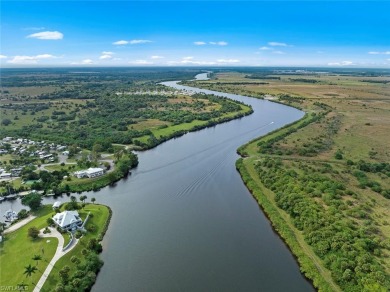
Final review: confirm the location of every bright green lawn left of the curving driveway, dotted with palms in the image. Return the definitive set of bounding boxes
[0,206,58,291]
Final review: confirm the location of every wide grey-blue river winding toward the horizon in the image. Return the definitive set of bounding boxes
[0,75,314,292]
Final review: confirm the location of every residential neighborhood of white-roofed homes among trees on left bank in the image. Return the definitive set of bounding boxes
[0,137,138,202]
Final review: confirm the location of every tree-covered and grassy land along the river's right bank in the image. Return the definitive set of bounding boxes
[201,73,390,291]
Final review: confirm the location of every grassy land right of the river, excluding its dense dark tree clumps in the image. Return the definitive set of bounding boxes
[193,72,390,291]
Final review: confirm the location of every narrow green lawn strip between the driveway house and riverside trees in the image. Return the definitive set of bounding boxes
[41,204,110,292]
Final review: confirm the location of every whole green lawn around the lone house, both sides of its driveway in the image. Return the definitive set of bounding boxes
[0,204,110,291]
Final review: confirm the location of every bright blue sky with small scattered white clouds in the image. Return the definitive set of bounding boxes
[0,0,390,68]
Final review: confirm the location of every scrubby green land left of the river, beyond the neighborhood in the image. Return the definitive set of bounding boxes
[0,69,250,151]
